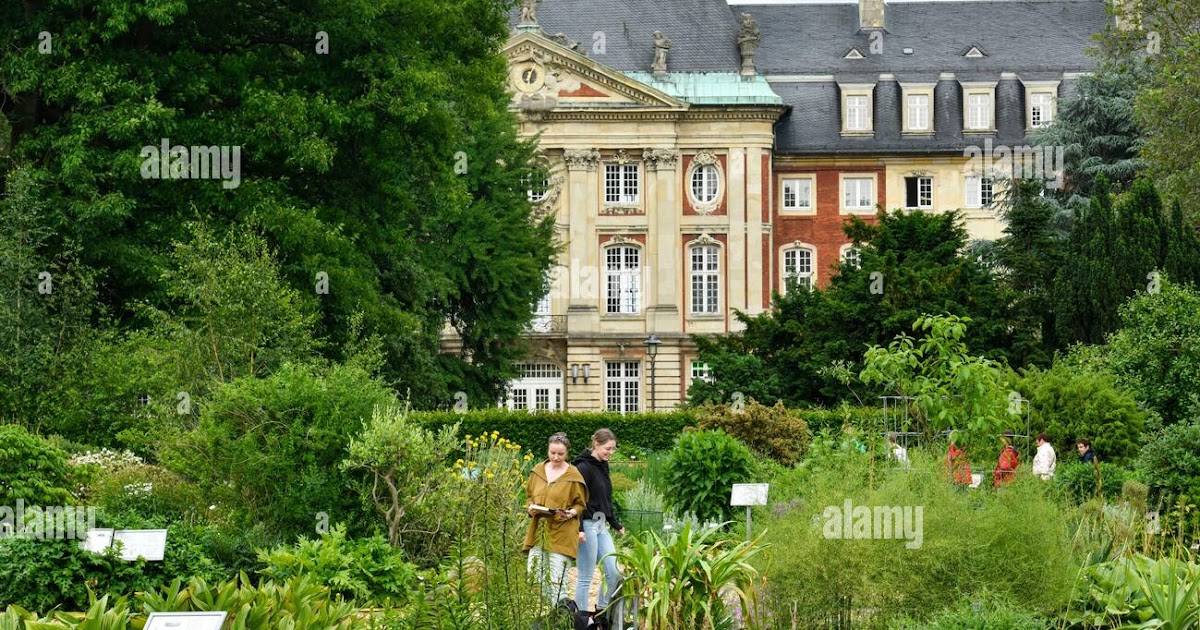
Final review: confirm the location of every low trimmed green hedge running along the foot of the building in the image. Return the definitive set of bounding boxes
[413,407,882,454]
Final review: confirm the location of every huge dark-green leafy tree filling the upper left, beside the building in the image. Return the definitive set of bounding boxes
[0,0,553,406]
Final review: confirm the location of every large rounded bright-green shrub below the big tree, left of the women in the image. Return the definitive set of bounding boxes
[162,364,396,540]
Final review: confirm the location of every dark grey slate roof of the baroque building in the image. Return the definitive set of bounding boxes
[512,0,1110,154]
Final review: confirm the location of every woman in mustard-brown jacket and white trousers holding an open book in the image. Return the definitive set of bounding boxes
[524,433,588,606]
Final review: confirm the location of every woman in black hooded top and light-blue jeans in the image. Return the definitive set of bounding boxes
[571,428,625,628]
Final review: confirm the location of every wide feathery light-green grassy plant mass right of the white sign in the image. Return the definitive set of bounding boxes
[763,449,1078,628]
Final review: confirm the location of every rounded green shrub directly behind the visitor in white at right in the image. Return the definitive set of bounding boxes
[1016,361,1146,463]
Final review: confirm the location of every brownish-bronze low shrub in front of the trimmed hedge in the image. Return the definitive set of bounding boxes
[698,398,812,466]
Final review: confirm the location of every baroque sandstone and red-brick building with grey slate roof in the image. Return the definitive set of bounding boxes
[444,0,1110,412]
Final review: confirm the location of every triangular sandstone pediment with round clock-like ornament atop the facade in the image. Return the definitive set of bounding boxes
[502,31,688,114]
